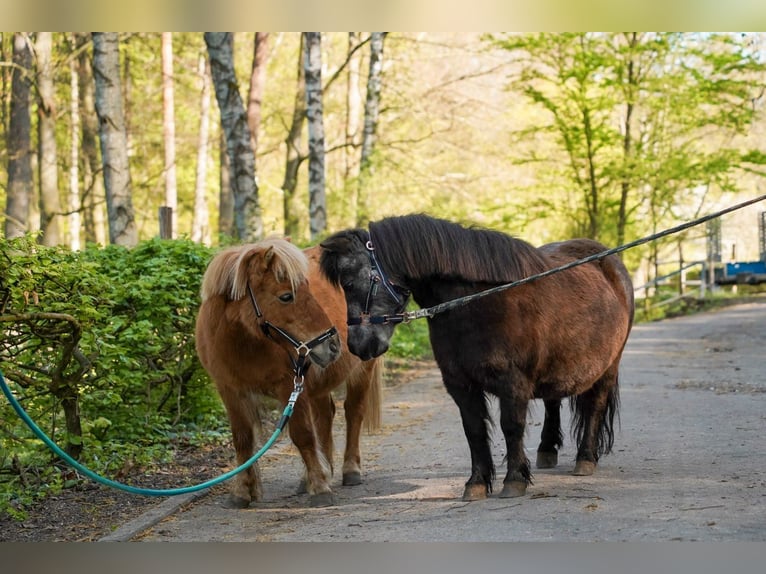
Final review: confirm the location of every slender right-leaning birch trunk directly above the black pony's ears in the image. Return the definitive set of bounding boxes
[356,32,386,227]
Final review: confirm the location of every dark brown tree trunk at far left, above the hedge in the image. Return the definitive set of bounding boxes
[5,32,32,239]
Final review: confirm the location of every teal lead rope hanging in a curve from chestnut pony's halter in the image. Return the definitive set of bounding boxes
[0,371,303,496]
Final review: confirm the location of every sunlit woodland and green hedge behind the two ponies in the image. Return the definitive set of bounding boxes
[0,32,766,512]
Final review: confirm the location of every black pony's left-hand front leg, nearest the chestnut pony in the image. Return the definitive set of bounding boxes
[445,380,495,501]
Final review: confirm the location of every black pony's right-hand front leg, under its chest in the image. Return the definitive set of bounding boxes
[500,397,532,498]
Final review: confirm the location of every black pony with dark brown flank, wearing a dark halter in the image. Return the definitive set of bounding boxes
[321,215,634,500]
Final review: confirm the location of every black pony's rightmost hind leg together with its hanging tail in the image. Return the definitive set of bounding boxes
[571,364,620,476]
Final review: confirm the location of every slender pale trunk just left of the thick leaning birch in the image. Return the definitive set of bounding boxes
[191,54,210,250]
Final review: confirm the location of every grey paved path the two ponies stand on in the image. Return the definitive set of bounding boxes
[0,302,766,542]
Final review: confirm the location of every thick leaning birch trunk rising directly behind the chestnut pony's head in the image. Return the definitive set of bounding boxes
[205,32,263,241]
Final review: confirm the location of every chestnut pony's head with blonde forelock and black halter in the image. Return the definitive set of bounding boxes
[201,238,341,367]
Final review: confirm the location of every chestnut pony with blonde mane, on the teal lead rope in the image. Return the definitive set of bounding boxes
[196,238,381,508]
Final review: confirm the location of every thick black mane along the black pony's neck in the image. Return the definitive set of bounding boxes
[369,214,548,284]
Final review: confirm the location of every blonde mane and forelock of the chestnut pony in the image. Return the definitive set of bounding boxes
[200,237,308,301]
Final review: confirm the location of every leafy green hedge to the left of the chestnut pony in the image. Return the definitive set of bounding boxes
[0,236,227,512]
